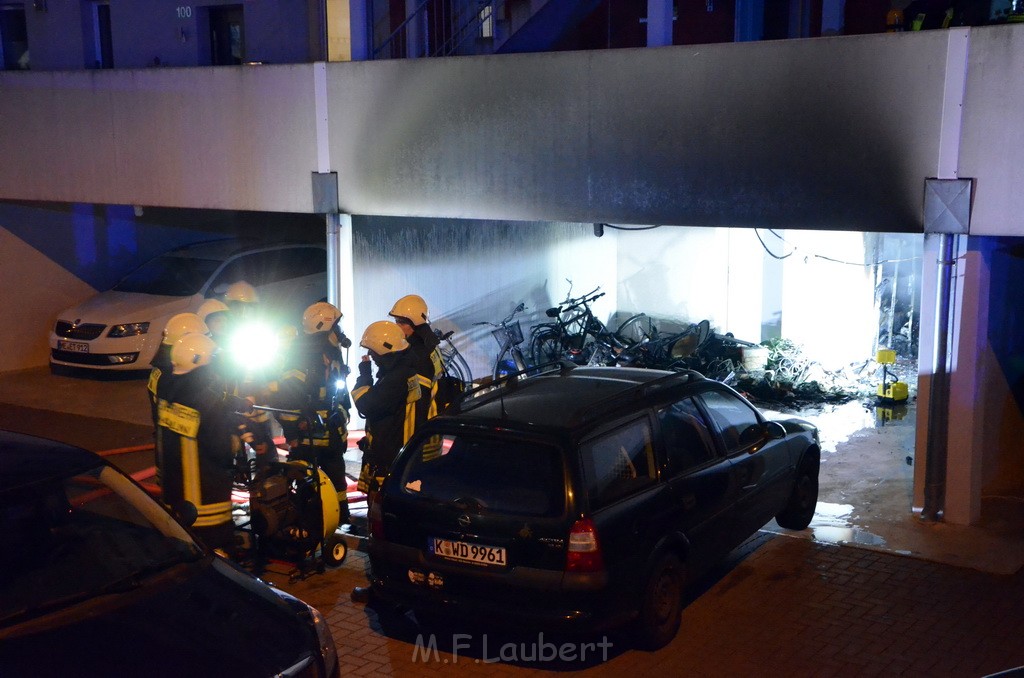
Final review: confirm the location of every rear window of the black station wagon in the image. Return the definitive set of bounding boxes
[399,433,565,516]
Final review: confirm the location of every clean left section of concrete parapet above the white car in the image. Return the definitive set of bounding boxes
[0,66,316,213]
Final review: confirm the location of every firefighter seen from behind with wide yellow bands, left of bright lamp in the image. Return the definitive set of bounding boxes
[157,333,248,555]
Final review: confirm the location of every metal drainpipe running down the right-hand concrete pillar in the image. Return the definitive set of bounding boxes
[921,234,955,520]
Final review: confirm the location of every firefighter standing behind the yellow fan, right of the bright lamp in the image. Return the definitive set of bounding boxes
[264,301,351,523]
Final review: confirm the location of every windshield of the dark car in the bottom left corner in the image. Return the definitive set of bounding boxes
[0,466,203,627]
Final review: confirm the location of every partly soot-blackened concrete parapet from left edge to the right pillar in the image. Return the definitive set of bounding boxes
[0,29,962,231]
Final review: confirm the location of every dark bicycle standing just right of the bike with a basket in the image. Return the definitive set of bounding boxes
[529,287,611,365]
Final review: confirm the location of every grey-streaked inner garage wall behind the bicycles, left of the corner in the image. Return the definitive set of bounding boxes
[343,218,616,378]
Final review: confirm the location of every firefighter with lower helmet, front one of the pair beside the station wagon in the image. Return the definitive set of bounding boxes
[351,321,419,602]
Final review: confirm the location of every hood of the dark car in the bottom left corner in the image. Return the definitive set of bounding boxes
[0,559,315,678]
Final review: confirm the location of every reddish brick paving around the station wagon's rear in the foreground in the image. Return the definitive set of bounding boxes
[266,533,1024,678]
